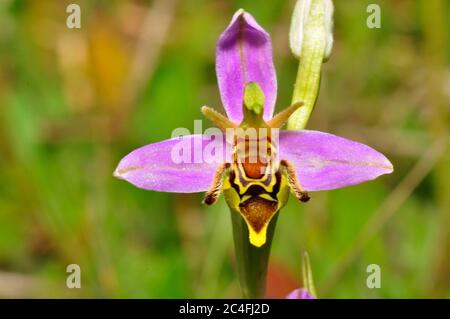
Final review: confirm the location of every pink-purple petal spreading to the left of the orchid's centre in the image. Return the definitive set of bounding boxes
[114,135,230,193]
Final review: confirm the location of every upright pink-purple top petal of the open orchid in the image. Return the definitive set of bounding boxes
[216,10,277,123]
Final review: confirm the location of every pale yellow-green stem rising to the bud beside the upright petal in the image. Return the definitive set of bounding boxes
[288,0,326,130]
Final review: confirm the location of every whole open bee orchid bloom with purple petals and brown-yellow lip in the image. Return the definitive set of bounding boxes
[114,10,393,247]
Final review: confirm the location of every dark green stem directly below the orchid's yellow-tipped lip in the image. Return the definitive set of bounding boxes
[230,210,280,298]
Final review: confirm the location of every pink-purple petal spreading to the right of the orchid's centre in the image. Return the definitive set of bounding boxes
[279,130,393,191]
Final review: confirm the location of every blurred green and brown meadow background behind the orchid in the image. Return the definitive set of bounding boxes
[0,0,450,298]
